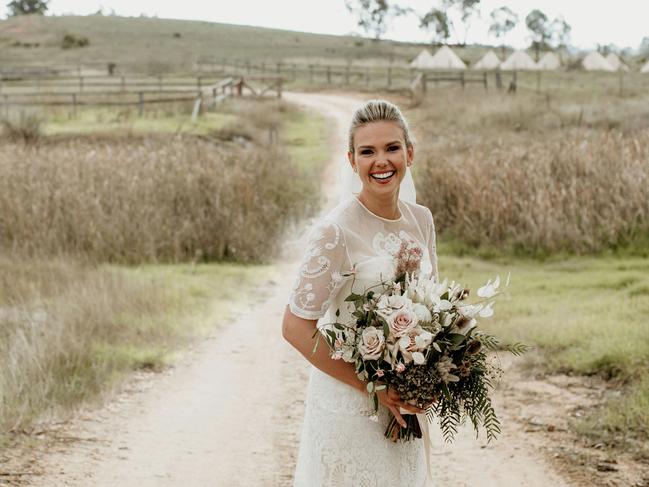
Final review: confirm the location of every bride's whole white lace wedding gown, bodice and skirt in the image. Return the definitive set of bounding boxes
[289,196,437,487]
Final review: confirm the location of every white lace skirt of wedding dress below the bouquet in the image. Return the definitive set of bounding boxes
[293,367,426,487]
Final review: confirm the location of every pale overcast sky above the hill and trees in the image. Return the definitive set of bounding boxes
[6,0,649,48]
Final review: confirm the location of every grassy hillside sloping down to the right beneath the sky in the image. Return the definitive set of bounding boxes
[0,15,492,72]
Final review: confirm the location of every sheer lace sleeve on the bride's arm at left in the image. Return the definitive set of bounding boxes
[288,221,352,320]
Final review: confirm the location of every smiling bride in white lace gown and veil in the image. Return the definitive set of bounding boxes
[282,100,437,487]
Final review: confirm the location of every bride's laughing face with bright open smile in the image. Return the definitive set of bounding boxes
[347,120,414,198]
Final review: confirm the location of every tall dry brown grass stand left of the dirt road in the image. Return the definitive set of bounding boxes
[0,132,315,263]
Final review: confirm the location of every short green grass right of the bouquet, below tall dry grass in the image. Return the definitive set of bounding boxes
[440,250,649,452]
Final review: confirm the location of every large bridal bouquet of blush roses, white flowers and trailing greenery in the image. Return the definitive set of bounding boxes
[316,242,528,442]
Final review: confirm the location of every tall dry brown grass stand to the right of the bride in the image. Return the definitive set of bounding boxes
[414,89,649,255]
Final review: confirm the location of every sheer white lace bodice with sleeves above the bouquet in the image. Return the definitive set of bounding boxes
[289,196,437,320]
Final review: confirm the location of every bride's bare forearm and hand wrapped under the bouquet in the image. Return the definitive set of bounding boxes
[282,306,425,427]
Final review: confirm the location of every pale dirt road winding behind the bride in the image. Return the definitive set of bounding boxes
[11,94,644,487]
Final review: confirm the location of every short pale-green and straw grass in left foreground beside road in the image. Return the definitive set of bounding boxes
[0,255,268,438]
